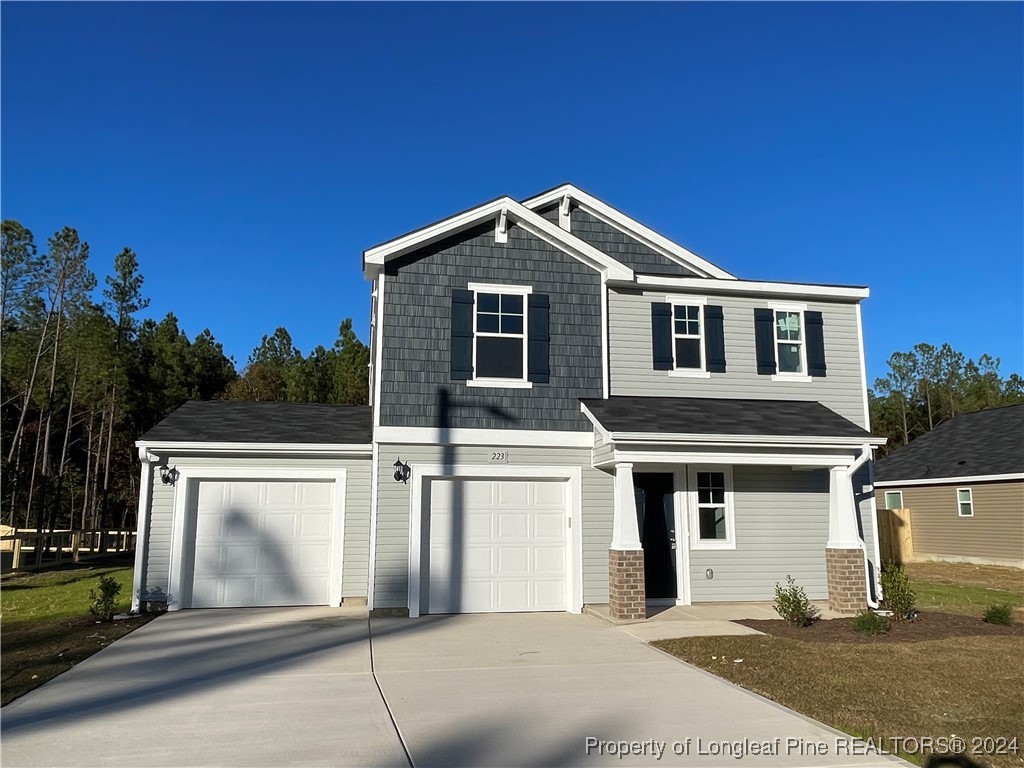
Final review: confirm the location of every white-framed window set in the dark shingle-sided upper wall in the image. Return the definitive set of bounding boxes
[466,283,532,389]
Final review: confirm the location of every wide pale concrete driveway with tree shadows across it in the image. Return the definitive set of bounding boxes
[0,608,909,768]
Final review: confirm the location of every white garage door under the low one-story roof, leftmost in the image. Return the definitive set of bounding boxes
[191,480,337,608]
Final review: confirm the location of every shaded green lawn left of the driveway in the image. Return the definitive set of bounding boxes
[0,555,154,706]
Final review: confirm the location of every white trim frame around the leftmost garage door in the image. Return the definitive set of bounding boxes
[167,466,348,610]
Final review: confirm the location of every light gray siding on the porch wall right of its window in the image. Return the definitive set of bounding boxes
[689,466,828,603]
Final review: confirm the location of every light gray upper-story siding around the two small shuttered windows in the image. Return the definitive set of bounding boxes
[608,290,866,427]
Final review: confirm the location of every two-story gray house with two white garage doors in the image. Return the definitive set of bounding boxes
[136,185,884,617]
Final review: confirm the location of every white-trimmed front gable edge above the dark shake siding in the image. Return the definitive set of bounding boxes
[362,197,633,281]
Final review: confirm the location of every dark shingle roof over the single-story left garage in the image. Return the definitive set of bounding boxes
[139,400,374,444]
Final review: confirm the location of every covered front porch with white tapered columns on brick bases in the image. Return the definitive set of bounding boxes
[583,397,883,621]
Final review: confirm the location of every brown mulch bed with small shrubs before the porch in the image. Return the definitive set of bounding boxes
[735,611,1024,643]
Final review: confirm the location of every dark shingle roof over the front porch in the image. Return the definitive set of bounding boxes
[582,397,870,439]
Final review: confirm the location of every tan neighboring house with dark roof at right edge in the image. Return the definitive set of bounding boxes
[874,404,1024,568]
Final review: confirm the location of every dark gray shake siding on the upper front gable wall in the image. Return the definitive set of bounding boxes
[377,224,603,431]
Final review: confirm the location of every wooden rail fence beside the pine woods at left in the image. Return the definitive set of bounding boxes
[0,528,135,570]
